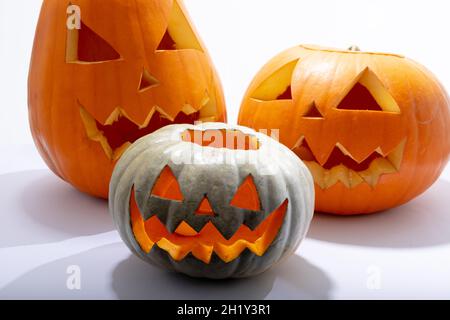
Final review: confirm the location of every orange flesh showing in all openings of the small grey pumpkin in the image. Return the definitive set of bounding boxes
[129,130,288,263]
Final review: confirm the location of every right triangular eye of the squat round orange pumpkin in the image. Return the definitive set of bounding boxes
[337,68,401,113]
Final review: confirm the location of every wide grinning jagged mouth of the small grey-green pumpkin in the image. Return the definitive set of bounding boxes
[130,190,288,264]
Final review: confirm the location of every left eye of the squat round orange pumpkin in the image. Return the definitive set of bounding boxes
[251,60,298,101]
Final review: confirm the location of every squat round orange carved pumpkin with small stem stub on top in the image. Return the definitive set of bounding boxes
[239,46,450,214]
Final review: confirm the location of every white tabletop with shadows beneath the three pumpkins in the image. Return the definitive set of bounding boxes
[0,145,450,299]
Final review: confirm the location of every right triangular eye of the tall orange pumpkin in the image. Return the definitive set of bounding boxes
[157,0,203,51]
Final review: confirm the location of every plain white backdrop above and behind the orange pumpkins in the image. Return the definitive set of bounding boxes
[0,0,450,144]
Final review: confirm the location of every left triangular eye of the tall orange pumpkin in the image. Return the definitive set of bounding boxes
[66,21,120,63]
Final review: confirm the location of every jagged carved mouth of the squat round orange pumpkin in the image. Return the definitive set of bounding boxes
[293,137,406,189]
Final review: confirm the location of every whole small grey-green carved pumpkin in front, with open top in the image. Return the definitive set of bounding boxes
[109,123,314,278]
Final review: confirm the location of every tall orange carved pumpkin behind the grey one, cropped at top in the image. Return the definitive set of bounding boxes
[29,0,226,198]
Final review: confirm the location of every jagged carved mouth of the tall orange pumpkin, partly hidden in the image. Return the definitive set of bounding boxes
[80,100,215,161]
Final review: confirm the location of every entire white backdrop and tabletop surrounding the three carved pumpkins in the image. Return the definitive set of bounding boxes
[0,0,450,299]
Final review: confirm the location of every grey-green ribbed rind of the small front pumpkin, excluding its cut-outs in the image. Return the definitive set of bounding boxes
[109,123,314,279]
